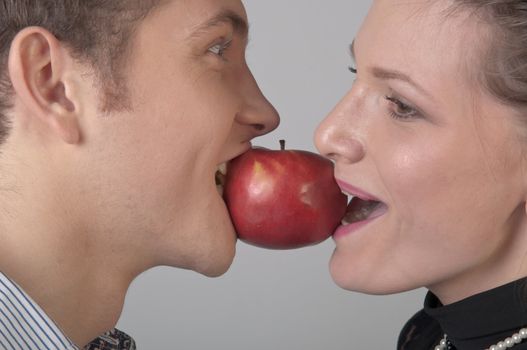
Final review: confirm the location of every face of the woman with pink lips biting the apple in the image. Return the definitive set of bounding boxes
[316,0,527,303]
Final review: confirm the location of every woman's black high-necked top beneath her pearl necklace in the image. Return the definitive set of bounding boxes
[397,279,527,350]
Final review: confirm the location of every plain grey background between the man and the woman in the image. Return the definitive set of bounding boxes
[118,0,424,350]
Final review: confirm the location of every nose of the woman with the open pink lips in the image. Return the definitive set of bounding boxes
[315,94,365,163]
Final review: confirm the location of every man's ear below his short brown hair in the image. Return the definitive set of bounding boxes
[8,27,81,144]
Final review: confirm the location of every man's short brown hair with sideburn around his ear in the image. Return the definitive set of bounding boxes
[0,0,161,142]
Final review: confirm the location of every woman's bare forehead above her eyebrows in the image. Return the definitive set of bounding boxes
[354,0,488,87]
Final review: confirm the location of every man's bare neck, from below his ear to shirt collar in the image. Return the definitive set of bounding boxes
[0,140,156,347]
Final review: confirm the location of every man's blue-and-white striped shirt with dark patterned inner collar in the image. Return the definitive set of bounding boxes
[0,272,136,350]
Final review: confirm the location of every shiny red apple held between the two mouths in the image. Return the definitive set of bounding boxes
[223,147,347,249]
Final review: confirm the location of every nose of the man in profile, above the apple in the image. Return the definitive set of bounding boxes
[236,68,280,137]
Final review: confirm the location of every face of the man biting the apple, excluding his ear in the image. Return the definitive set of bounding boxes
[77,0,279,276]
